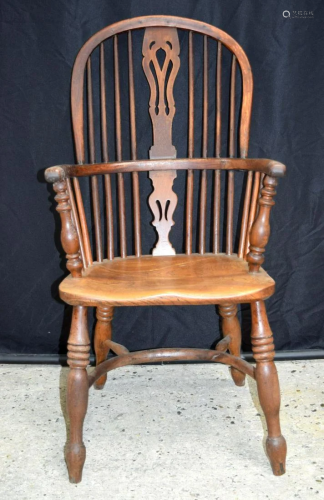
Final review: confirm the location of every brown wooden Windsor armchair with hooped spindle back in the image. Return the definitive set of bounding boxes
[45,16,286,482]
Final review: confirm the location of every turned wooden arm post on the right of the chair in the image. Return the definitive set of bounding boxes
[246,175,278,273]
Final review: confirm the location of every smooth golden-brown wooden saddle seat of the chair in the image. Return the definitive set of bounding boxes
[60,254,275,306]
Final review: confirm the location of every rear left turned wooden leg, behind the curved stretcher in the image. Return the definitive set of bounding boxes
[94,307,114,389]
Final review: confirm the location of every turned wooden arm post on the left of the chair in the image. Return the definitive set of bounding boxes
[45,167,82,278]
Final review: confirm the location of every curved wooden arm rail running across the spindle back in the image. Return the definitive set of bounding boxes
[45,158,286,183]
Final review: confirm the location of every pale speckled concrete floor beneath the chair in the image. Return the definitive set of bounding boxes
[0,360,324,500]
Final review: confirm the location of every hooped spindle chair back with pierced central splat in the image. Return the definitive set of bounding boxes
[68,16,260,267]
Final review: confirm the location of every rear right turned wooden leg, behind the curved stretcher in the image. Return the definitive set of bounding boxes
[219,304,245,386]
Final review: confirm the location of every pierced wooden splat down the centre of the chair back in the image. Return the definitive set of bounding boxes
[143,28,180,255]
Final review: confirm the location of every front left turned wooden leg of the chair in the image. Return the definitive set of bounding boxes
[65,306,90,483]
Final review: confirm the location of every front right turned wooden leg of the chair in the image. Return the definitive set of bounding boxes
[251,301,287,476]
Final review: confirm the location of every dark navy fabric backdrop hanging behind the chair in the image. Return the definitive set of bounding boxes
[0,0,324,354]
